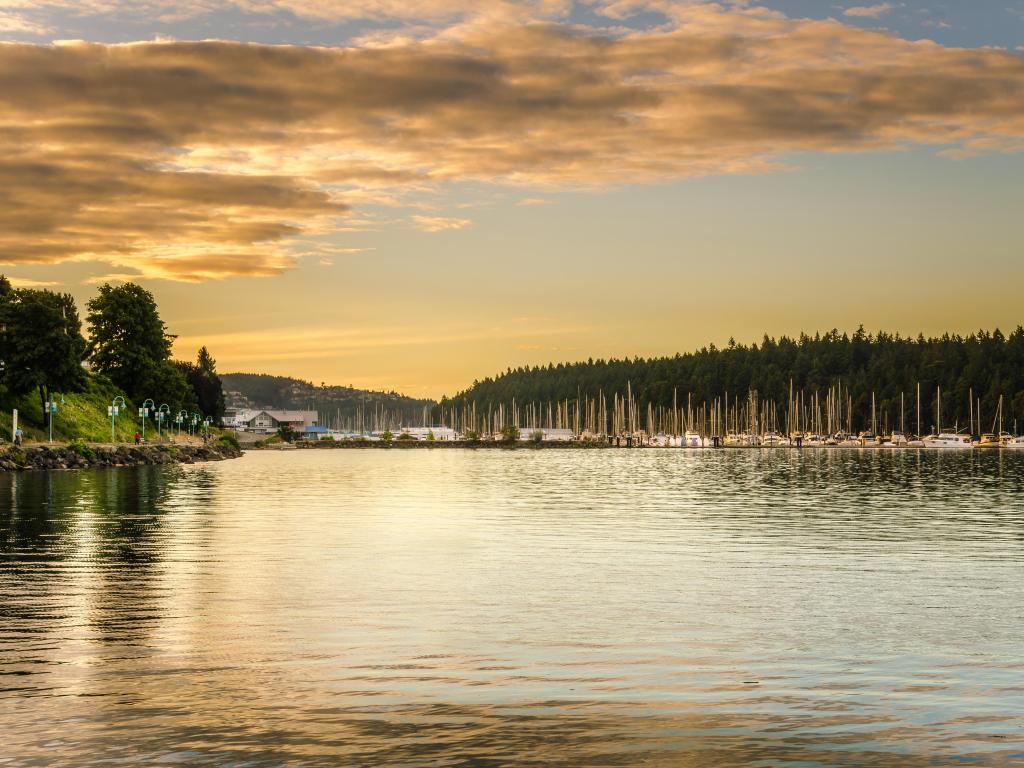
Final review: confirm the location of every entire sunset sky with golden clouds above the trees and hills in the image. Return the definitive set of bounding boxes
[0,0,1024,397]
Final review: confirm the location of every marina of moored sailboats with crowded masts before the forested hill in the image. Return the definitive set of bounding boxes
[270,383,1024,451]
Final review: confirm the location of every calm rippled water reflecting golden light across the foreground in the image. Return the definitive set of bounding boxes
[0,450,1024,767]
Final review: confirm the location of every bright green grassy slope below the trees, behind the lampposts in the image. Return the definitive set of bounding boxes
[0,376,157,442]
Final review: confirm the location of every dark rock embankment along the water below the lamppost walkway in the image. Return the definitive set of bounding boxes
[0,443,242,472]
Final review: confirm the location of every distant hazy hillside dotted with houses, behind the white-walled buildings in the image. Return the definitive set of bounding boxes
[220,373,434,429]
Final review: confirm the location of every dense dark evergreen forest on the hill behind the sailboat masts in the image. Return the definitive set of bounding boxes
[443,327,1024,438]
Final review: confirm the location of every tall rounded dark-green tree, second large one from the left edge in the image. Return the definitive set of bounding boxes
[88,283,178,402]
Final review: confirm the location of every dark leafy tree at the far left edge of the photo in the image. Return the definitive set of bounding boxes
[0,286,86,420]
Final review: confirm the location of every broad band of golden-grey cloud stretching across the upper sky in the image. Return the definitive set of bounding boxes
[0,3,1024,281]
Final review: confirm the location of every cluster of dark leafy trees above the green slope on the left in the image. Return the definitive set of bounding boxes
[0,275,224,434]
